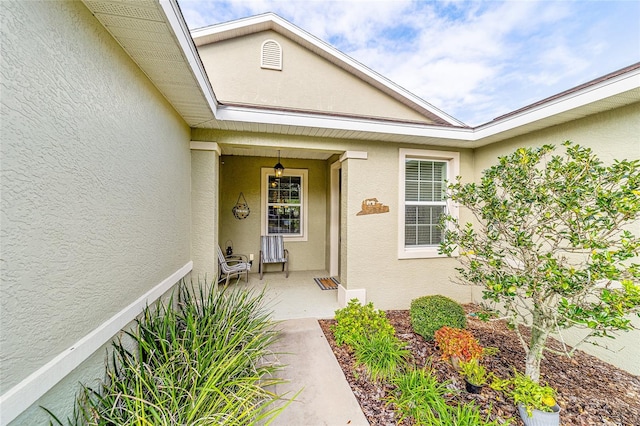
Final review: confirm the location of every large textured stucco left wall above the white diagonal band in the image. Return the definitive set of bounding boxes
[0,1,190,406]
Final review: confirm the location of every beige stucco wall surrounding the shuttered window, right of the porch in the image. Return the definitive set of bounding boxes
[342,143,473,309]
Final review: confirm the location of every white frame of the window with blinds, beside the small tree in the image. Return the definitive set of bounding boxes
[398,148,460,259]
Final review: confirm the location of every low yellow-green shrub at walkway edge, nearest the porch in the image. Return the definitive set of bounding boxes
[331,299,395,346]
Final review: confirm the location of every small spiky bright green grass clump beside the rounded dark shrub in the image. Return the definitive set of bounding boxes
[354,334,410,380]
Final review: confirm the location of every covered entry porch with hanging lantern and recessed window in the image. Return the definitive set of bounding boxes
[191,136,376,306]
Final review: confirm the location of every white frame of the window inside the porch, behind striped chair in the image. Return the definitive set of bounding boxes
[260,167,309,242]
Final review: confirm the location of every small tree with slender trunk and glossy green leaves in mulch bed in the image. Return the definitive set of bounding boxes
[440,142,640,382]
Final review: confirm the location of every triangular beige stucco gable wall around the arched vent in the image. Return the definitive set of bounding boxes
[198,31,431,123]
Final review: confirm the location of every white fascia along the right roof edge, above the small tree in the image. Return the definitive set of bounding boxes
[473,70,640,141]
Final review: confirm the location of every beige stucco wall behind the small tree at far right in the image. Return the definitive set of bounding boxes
[475,103,640,374]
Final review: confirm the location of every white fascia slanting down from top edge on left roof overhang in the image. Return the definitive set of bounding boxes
[159,0,218,116]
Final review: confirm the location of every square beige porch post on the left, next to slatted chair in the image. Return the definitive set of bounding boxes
[191,141,221,283]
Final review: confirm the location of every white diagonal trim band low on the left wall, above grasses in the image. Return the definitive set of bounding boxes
[0,261,193,425]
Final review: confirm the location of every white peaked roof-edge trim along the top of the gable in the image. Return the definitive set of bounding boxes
[191,13,465,126]
